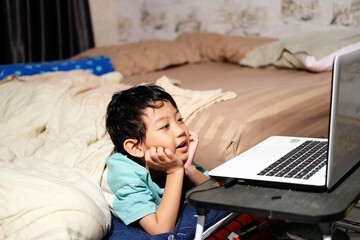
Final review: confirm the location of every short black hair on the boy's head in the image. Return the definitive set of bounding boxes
[106,84,177,155]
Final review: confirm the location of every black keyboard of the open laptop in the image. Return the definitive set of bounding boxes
[257,141,327,179]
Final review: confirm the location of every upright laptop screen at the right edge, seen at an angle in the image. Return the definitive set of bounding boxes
[327,51,360,189]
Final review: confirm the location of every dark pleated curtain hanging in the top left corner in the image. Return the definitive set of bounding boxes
[0,0,94,64]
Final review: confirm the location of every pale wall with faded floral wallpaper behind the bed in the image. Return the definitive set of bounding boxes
[116,0,360,42]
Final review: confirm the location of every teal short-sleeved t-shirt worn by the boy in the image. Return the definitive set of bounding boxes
[104,153,164,225]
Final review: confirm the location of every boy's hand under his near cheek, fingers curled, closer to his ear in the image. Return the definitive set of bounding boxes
[145,147,183,174]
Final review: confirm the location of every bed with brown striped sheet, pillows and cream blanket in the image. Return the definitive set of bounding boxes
[0,30,360,239]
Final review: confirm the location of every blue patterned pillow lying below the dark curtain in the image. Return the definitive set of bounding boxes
[0,56,113,80]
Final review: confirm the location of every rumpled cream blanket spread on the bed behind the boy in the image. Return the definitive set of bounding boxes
[0,70,235,239]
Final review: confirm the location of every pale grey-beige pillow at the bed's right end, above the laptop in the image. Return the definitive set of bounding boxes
[240,30,360,72]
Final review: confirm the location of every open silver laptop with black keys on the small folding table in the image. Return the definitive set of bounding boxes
[209,50,360,191]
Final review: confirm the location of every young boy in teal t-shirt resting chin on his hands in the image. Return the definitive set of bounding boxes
[104,84,208,235]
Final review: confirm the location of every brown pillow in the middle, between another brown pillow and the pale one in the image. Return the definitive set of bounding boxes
[176,32,276,63]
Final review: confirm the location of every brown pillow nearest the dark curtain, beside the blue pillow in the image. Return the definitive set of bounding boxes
[73,40,200,76]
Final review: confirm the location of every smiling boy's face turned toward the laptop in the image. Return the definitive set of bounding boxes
[142,102,190,162]
